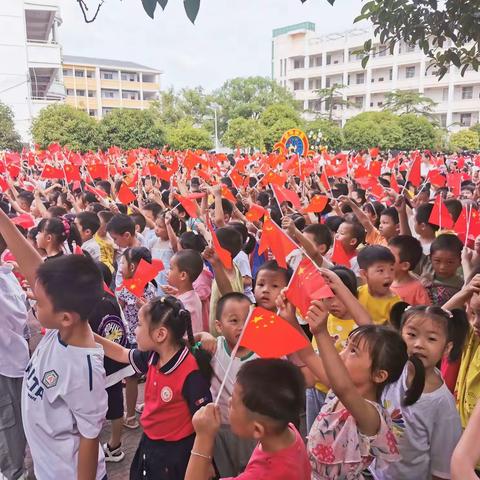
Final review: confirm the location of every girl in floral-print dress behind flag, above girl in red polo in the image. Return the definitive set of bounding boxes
[117,247,155,429]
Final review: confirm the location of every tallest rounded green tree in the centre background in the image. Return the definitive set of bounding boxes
[213,77,298,132]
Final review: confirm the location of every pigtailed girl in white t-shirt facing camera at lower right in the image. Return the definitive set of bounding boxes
[372,304,468,480]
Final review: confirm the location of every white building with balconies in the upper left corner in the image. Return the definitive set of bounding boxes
[0,0,65,141]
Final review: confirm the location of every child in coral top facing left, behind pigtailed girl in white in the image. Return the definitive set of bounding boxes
[388,235,432,306]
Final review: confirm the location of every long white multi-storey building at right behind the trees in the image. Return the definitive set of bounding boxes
[272,22,480,131]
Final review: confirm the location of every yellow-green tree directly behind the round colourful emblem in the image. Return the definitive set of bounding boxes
[260,103,301,150]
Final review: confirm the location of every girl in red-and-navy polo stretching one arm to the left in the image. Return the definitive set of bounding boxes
[96,296,211,480]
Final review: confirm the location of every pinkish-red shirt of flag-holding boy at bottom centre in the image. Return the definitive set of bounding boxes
[222,424,311,480]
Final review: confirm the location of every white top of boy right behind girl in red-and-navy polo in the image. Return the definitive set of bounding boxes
[210,336,258,425]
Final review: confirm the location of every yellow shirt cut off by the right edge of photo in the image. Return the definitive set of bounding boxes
[455,329,480,428]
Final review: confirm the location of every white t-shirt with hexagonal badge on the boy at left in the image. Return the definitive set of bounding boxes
[22,330,107,480]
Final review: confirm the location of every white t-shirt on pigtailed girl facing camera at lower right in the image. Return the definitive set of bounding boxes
[371,367,462,480]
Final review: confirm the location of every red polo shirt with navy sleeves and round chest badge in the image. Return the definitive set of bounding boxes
[130,347,212,442]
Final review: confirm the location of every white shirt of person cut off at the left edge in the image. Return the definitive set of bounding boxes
[0,265,29,378]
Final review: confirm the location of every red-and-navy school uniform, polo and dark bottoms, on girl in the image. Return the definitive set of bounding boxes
[129,347,212,480]
